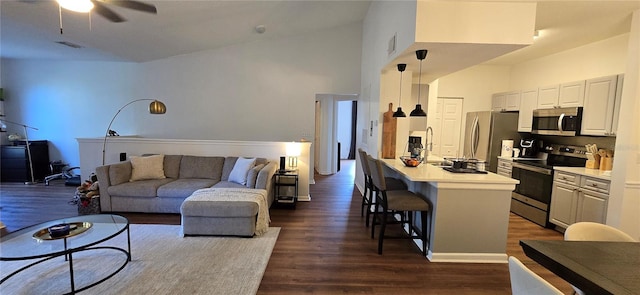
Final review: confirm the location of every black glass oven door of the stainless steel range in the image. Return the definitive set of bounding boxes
[511,162,553,209]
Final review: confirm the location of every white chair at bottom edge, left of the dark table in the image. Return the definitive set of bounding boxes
[509,256,563,295]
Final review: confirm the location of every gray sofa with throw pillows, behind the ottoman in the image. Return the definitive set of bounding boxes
[96,155,277,213]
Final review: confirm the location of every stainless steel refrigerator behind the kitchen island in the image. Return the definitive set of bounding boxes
[464,111,520,173]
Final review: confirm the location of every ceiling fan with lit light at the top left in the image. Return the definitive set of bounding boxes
[56,0,158,23]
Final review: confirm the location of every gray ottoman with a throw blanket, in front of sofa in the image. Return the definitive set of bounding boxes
[180,189,268,237]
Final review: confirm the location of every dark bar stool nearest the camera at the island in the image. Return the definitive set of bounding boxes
[367,156,431,256]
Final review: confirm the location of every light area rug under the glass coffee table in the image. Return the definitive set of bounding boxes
[0,224,280,294]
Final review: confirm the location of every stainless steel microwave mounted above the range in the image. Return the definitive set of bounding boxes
[531,107,582,136]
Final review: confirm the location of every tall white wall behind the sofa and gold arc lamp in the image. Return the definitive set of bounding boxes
[2,24,362,176]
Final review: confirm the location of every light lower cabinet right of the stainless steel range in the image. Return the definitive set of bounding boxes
[549,172,610,228]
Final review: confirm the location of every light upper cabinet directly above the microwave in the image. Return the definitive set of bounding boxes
[538,80,585,109]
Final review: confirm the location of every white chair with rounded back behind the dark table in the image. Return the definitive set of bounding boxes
[564,221,636,295]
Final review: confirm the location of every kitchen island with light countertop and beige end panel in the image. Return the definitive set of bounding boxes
[382,159,518,263]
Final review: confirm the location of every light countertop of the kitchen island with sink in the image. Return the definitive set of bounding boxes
[382,160,518,184]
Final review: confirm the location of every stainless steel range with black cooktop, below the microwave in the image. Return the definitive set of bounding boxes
[511,145,587,228]
